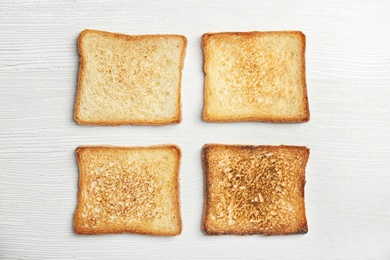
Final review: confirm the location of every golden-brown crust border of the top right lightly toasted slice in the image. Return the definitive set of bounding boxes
[202,31,310,123]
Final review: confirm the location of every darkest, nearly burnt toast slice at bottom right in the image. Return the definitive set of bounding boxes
[202,144,309,235]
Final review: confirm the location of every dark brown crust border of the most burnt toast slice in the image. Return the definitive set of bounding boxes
[201,144,310,236]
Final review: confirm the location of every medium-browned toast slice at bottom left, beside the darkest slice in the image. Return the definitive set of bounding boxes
[74,145,182,236]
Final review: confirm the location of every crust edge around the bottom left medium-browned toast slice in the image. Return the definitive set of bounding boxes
[73,144,183,237]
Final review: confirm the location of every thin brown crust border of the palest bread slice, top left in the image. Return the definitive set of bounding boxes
[73,29,188,126]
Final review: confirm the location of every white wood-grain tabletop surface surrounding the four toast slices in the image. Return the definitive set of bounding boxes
[0,0,390,259]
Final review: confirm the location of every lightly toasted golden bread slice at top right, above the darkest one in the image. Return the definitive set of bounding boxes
[202,31,310,123]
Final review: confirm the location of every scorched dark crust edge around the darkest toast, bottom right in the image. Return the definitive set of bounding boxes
[202,143,310,236]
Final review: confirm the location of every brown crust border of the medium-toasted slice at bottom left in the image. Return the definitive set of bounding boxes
[74,144,182,236]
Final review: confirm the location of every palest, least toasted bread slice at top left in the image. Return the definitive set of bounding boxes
[74,30,187,125]
